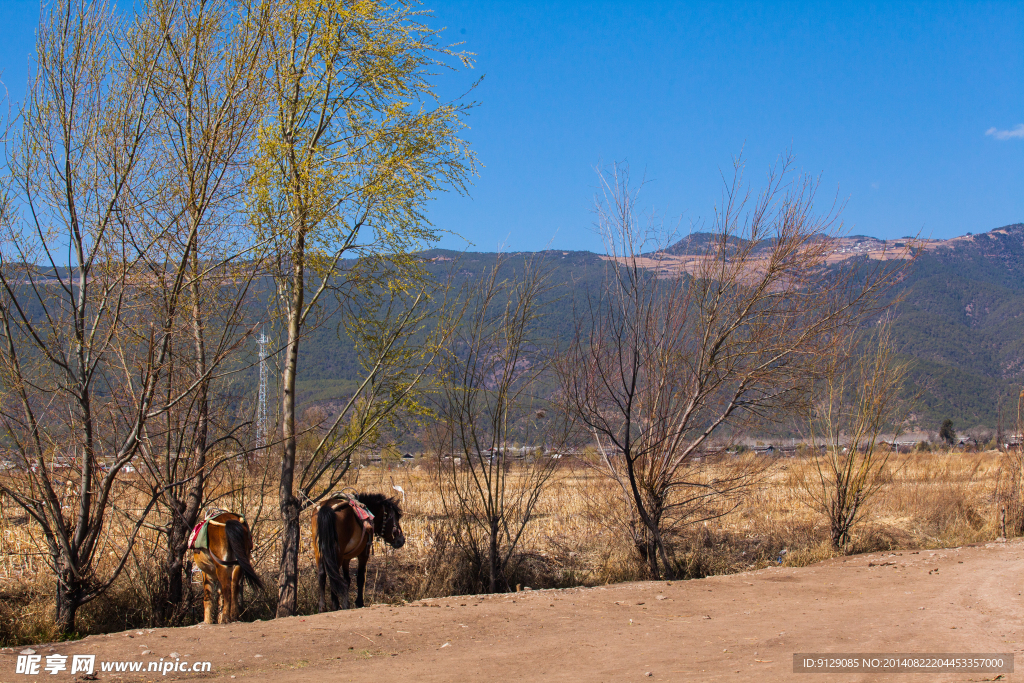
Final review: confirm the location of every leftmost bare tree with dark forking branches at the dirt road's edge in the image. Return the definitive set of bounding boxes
[0,0,172,633]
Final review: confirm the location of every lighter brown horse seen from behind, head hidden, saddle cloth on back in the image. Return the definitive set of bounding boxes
[193,512,263,624]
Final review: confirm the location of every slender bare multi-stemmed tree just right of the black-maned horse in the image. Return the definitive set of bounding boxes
[431,258,568,593]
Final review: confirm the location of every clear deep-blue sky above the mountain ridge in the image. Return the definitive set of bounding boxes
[0,0,1024,251]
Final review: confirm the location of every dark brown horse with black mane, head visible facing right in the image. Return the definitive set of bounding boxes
[313,494,406,611]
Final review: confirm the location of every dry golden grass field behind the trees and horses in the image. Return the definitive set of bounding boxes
[0,451,1016,645]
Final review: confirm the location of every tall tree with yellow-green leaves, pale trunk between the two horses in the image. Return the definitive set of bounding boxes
[254,0,472,616]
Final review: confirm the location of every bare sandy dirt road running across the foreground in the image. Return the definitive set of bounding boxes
[0,542,1024,683]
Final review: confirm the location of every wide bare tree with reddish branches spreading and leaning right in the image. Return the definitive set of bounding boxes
[560,162,901,578]
